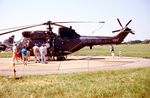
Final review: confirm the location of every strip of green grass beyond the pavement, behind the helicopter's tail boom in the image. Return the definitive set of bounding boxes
[73,44,150,58]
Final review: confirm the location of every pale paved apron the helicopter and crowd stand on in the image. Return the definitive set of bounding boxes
[0,56,150,77]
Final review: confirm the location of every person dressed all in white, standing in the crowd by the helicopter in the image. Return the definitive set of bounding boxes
[39,44,46,64]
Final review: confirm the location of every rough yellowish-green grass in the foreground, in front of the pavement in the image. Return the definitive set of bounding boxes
[0,68,150,98]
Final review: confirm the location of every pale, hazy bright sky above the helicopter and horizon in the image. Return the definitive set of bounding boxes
[0,0,150,41]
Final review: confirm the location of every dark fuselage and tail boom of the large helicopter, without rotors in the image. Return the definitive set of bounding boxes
[15,25,130,57]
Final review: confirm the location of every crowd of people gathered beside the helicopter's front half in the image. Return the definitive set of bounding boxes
[13,40,55,65]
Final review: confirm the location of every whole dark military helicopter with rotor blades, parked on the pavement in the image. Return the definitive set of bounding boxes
[0,18,135,60]
